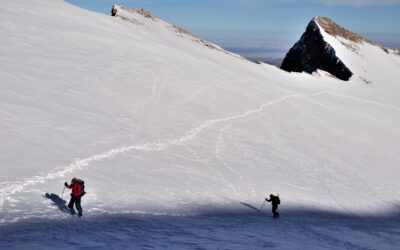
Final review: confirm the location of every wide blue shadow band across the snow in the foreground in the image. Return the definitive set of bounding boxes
[0,202,400,249]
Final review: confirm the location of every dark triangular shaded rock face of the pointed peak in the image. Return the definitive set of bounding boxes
[281,18,353,81]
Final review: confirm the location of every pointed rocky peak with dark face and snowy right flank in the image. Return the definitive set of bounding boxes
[281,17,400,84]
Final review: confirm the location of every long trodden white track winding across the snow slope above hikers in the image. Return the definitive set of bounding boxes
[0,91,400,210]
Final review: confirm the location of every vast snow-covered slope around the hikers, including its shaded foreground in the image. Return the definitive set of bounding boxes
[0,0,400,249]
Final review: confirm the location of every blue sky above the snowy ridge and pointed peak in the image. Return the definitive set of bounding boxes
[67,0,400,61]
